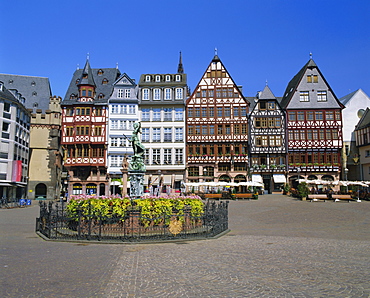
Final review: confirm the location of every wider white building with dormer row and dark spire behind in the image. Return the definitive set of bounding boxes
[139,53,188,194]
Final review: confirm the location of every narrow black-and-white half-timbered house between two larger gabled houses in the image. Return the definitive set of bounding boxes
[249,85,286,193]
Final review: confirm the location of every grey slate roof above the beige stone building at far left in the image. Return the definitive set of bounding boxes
[0,74,51,113]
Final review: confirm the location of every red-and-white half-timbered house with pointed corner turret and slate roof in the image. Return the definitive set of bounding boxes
[61,61,120,195]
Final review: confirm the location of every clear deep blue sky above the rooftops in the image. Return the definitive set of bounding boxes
[0,0,370,98]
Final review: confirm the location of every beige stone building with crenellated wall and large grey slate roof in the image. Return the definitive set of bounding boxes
[0,74,62,199]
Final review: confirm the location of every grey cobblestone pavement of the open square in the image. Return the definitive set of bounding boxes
[0,195,370,297]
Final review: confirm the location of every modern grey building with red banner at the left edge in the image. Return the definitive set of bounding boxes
[0,81,31,200]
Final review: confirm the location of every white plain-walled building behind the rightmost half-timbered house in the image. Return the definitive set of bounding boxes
[339,89,370,181]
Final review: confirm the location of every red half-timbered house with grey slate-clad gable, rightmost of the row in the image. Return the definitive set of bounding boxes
[281,58,344,185]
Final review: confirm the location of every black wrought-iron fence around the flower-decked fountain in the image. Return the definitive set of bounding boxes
[36,201,228,242]
